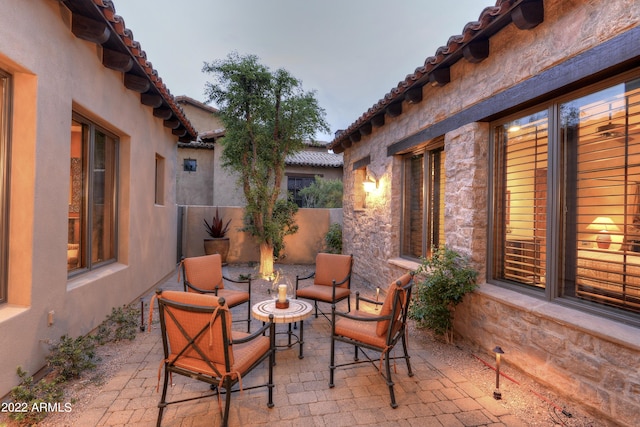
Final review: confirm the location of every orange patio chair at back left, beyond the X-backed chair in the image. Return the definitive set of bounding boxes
[182,254,251,332]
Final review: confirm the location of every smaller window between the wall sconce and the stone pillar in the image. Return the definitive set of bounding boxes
[401,139,445,259]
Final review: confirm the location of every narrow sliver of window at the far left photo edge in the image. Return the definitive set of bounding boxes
[0,70,11,303]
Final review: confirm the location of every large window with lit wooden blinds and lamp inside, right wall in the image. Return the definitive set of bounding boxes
[492,73,640,316]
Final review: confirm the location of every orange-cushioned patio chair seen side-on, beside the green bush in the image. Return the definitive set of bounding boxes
[329,273,413,408]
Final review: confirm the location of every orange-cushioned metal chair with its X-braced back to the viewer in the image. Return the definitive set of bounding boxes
[156,291,275,427]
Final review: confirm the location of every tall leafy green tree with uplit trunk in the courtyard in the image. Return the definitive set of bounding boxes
[202,52,329,277]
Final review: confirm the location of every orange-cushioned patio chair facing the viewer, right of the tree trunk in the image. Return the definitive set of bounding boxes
[296,253,353,319]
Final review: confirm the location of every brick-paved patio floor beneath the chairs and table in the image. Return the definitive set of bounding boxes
[43,266,529,426]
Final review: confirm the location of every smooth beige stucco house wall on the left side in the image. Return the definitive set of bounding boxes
[0,0,182,396]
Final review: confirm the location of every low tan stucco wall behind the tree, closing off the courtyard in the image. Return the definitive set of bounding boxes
[182,206,342,264]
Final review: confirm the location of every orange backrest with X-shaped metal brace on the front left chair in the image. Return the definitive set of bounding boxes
[158,291,234,374]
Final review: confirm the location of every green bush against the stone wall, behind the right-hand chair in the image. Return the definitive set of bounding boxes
[409,247,478,343]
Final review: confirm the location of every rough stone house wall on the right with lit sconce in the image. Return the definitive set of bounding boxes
[344,0,640,425]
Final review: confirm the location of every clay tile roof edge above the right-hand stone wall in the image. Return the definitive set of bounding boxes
[329,0,521,148]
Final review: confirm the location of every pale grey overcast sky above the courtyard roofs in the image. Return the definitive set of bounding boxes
[113,0,495,141]
